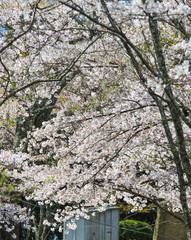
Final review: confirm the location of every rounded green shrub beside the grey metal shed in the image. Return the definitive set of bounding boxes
[119,220,153,240]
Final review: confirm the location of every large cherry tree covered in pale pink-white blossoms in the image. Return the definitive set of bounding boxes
[0,0,191,240]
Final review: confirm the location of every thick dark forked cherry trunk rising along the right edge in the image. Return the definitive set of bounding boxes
[149,16,191,240]
